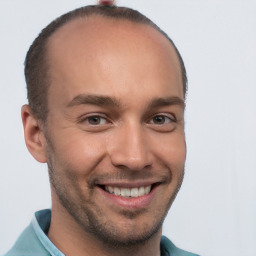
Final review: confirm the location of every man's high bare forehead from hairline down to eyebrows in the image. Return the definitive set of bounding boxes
[47,16,183,105]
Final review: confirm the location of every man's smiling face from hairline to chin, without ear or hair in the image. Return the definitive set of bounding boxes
[46,17,186,245]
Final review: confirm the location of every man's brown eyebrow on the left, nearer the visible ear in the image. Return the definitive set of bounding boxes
[67,94,121,108]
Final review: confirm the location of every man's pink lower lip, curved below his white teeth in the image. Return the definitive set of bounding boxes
[98,187,157,209]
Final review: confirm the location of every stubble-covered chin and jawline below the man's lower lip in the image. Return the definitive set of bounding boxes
[58,188,168,248]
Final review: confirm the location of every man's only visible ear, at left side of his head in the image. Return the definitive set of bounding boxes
[21,105,47,163]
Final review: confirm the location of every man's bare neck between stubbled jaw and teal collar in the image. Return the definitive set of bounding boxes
[48,195,161,256]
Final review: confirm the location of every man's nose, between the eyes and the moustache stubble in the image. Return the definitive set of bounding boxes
[108,121,153,171]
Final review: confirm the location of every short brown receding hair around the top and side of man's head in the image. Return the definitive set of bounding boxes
[25,5,187,122]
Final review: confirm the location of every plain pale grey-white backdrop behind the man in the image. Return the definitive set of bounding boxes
[0,0,256,256]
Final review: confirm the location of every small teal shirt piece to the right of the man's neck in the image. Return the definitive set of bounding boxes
[161,236,199,256]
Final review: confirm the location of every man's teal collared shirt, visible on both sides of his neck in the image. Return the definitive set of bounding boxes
[3,210,198,256]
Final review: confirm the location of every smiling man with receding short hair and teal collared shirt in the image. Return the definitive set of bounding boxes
[6,1,199,256]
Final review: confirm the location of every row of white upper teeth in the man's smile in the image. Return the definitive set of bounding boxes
[105,185,151,197]
